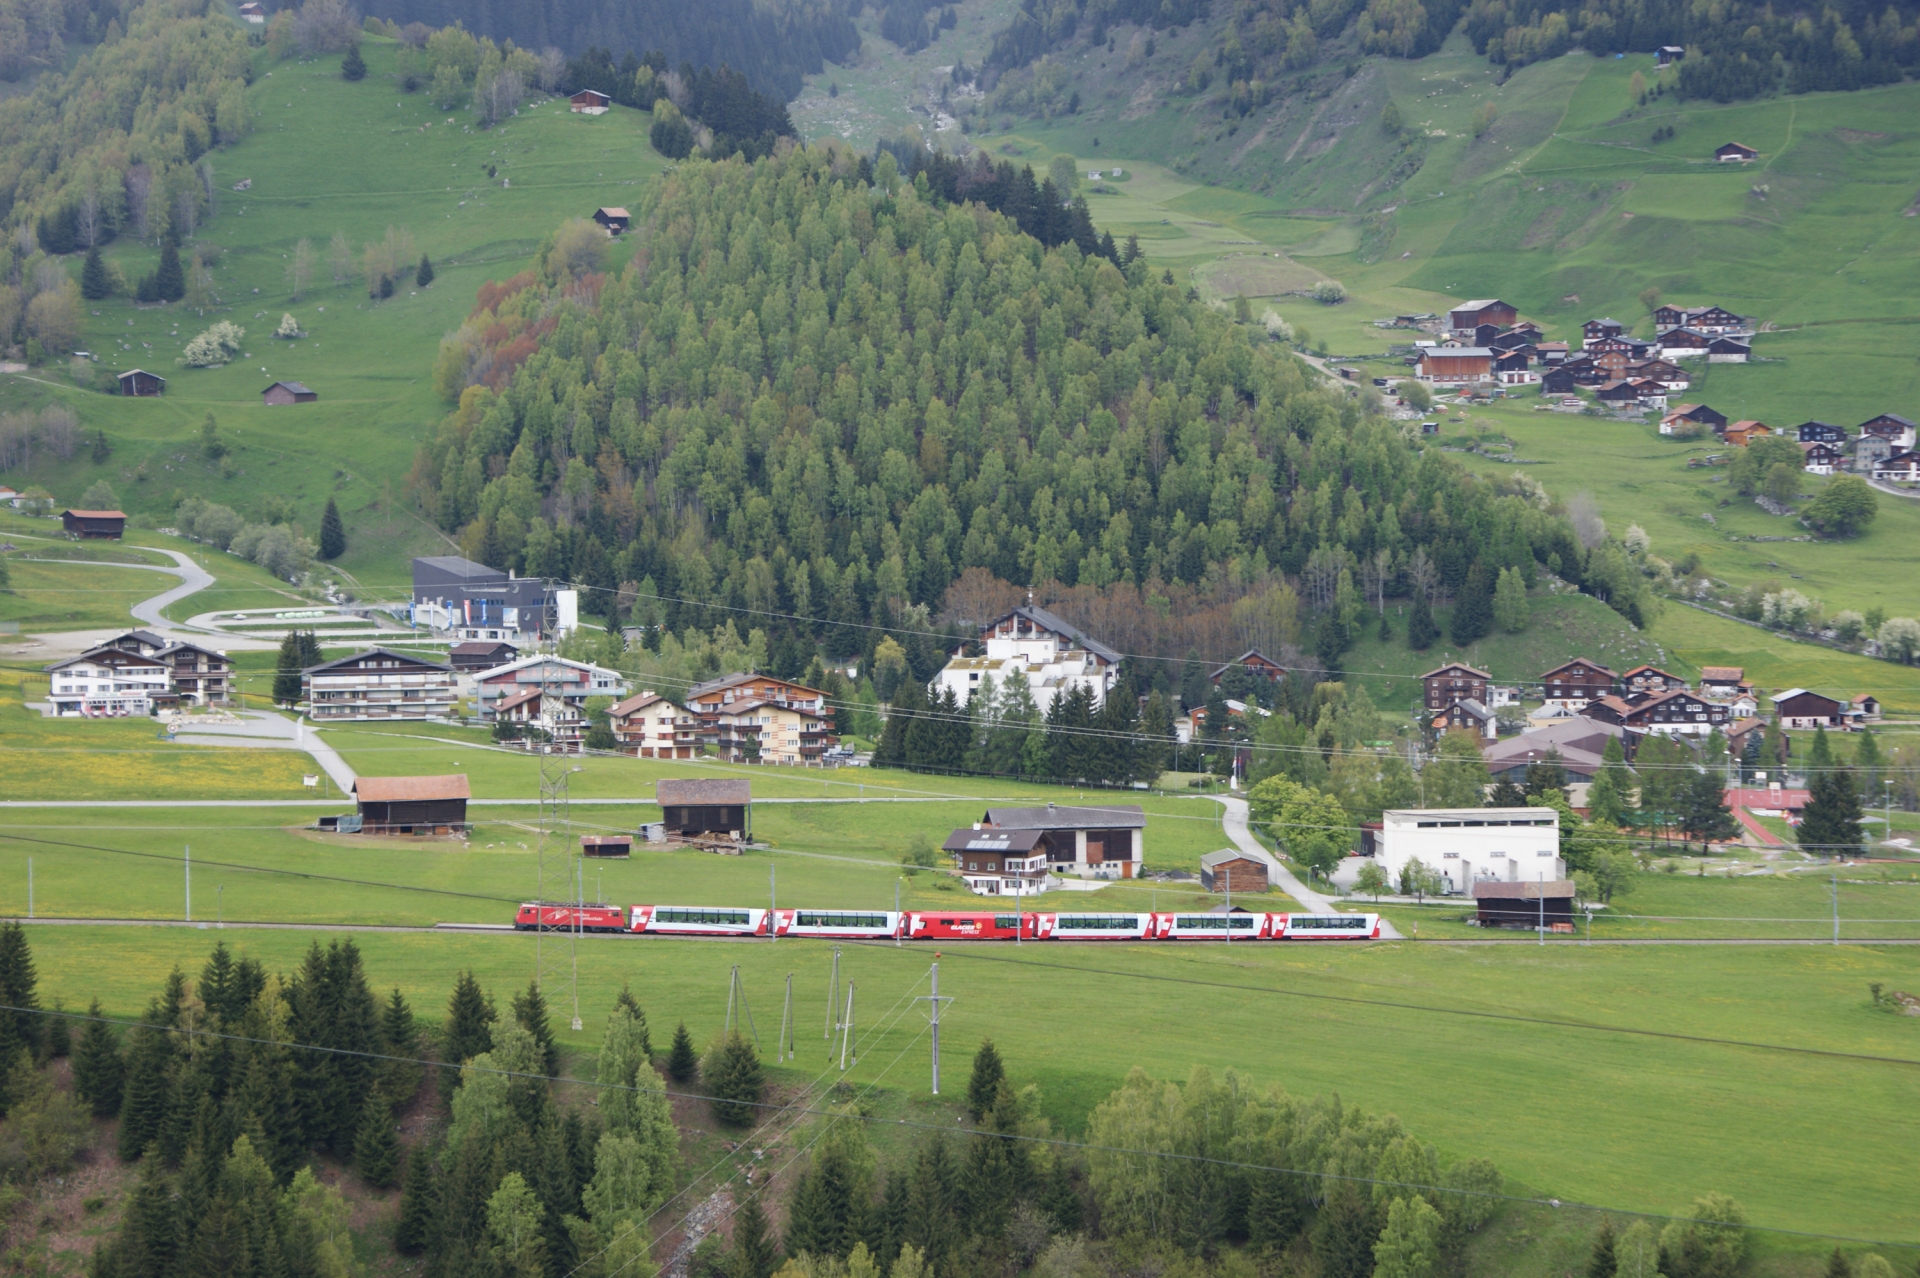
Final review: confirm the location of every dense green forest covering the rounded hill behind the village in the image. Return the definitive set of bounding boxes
[411,148,1644,686]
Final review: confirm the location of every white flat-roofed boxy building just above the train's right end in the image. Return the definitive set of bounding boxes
[1375,808,1567,894]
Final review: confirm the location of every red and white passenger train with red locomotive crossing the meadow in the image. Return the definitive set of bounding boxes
[513,902,1380,942]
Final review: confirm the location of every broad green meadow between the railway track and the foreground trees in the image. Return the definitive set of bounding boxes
[18,927,1920,1243]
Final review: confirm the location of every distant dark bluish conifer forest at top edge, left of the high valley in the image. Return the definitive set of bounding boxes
[362,0,860,102]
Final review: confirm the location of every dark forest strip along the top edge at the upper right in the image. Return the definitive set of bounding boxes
[985,0,1920,102]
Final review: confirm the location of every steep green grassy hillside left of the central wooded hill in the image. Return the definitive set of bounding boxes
[0,38,664,583]
